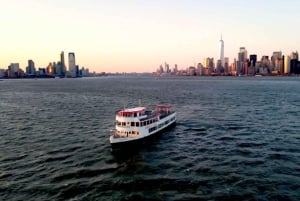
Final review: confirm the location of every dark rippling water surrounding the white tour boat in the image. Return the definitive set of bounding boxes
[0,76,300,200]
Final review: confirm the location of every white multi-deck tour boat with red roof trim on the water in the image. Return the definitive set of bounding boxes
[109,105,176,147]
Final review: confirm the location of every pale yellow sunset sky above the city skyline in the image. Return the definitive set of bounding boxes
[0,0,300,73]
